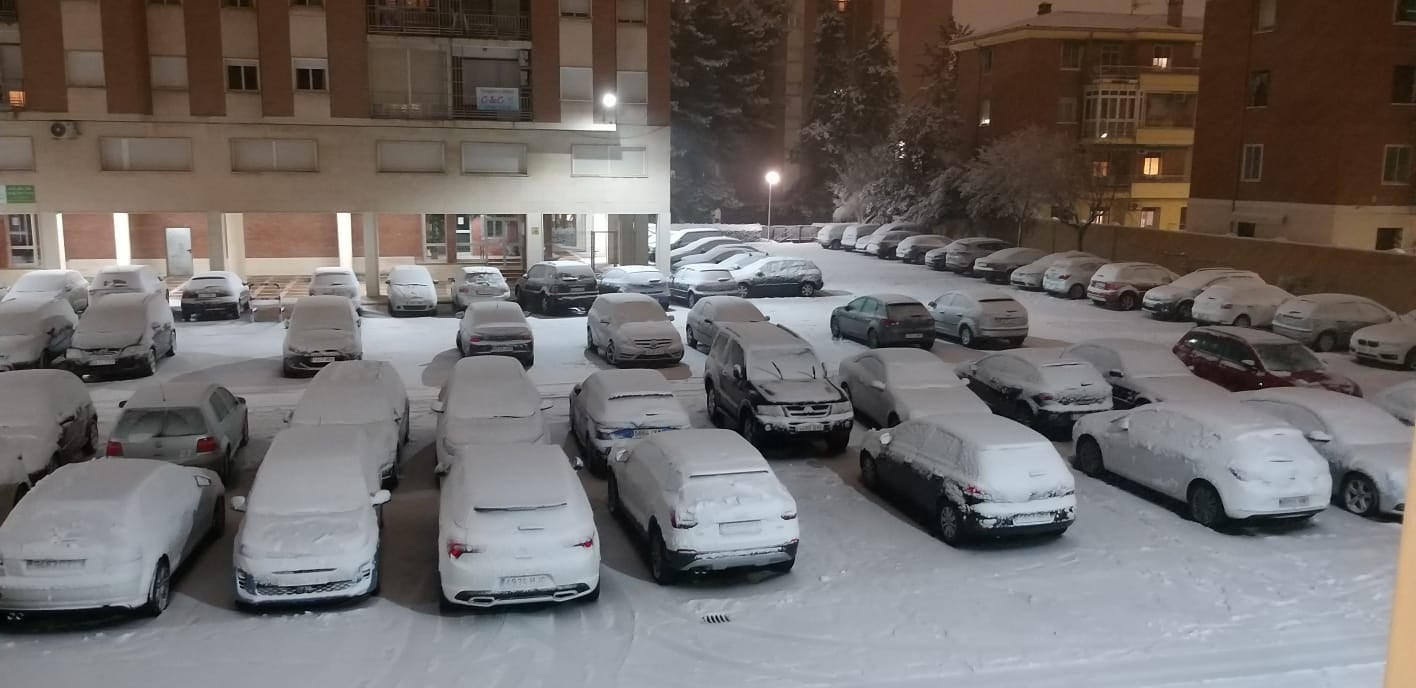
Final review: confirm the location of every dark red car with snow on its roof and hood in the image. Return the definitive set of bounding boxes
[1174,326,1362,396]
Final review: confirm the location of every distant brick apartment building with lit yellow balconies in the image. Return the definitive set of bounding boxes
[952,0,1202,229]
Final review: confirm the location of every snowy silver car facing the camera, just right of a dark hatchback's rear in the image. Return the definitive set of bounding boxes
[585,294,684,367]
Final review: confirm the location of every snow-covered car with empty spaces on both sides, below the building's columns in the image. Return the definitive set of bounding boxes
[282,296,364,378]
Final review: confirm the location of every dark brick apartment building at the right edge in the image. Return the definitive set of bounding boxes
[1189,0,1416,251]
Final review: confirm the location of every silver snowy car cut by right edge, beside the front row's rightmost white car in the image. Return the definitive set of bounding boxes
[1235,386,1412,517]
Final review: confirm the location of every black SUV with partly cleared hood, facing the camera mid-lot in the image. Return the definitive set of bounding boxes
[704,323,854,454]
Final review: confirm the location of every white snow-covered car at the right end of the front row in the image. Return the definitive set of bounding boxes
[1072,399,1332,528]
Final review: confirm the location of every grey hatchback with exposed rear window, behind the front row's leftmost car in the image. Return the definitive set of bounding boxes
[103,382,251,481]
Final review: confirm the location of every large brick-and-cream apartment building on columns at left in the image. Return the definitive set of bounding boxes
[0,0,670,294]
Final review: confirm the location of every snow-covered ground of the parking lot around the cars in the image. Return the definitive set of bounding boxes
[8,245,1412,688]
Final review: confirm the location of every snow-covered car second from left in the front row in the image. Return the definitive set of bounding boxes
[231,428,391,609]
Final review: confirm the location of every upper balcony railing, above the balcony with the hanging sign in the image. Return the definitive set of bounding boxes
[365,0,531,41]
